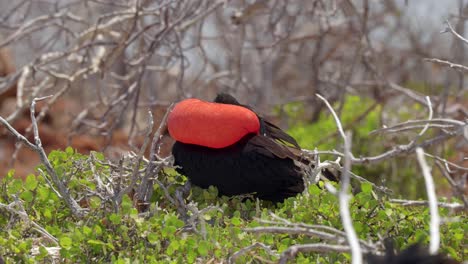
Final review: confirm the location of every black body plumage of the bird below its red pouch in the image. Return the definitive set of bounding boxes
[172,134,304,202]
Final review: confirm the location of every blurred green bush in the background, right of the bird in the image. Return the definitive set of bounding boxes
[285,96,450,199]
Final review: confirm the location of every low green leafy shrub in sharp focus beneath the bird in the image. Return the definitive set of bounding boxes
[0,149,468,263]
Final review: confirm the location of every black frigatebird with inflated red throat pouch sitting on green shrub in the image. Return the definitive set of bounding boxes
[168,94,304,202]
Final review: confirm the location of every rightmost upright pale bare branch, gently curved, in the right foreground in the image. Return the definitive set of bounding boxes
[416,148,440,254]
